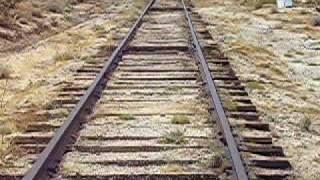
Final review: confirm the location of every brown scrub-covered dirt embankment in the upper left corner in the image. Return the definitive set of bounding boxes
[0,0,112,52]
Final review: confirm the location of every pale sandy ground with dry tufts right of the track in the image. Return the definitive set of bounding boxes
[194,0,320,180]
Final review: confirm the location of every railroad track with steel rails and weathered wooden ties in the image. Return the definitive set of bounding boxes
[0,0,292,180]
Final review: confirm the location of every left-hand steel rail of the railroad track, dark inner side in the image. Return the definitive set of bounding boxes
[23,0,154,180]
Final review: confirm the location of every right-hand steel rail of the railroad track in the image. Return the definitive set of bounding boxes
[181,0,249,180]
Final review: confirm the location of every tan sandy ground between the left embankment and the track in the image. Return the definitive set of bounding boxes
[0,0,146,165]
